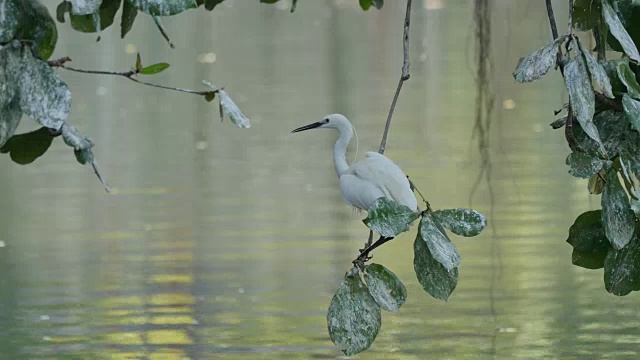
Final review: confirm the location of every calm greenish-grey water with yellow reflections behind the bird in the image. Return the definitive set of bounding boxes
[0,0,640,359]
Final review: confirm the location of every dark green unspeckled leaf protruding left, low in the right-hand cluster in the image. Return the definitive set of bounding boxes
[567,210,610,253]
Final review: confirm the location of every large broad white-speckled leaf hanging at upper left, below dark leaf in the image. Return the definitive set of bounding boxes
[18,48,71,130]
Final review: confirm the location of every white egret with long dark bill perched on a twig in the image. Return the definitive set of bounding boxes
[292,114,418,212]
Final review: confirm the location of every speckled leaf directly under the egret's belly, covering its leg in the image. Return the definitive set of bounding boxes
[363,197,419,238]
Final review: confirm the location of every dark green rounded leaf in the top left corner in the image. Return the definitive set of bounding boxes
[10,0,58,60]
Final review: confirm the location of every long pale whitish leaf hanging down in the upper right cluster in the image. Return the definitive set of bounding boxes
[564,56,602,152]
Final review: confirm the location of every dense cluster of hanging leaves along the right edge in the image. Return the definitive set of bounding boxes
[514,0,640,296]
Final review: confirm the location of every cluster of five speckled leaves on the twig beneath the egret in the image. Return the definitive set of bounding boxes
[327,197,486,356]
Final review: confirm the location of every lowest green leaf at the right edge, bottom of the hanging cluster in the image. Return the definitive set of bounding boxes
[604,236,640,296]
